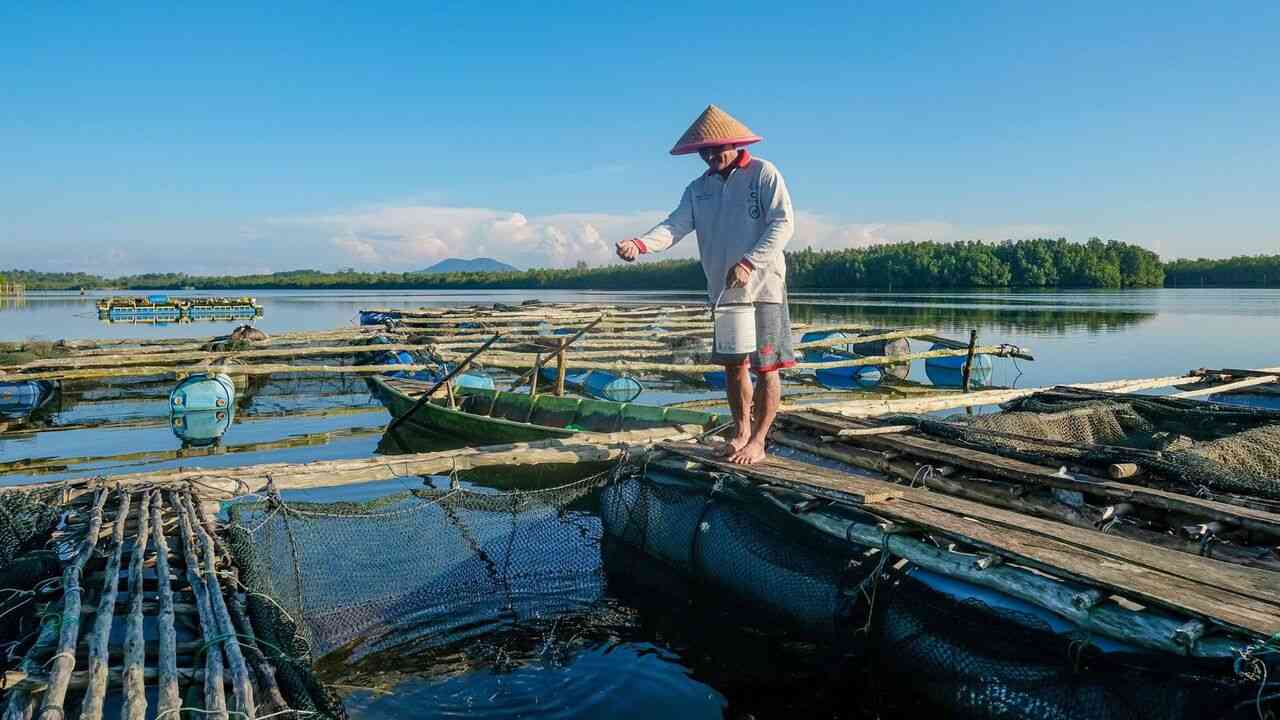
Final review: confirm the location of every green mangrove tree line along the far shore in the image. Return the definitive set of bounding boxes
[5,238,1280,291]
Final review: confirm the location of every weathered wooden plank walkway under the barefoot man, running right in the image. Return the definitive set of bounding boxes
[659,443,1280,635]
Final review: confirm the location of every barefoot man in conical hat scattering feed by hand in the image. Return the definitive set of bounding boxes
[617,105,795,465]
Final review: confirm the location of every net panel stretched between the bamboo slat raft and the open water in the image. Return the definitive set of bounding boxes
[227,461,611,717]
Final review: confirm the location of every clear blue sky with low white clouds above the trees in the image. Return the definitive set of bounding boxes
[0,1,1280,274]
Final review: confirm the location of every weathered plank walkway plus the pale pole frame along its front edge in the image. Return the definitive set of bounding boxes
[658,443,1280,656]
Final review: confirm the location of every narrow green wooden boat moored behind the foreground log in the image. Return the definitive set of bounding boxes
[369,375,722,443]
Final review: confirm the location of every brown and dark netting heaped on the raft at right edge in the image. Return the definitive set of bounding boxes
[913,388,1280,501]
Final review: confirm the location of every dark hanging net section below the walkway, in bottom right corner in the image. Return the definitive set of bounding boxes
[873,577,1258,720]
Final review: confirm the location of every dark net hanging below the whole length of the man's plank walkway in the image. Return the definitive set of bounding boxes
[600,458,1260,720]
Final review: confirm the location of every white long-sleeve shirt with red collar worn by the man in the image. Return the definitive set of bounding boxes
[639,150,795,302]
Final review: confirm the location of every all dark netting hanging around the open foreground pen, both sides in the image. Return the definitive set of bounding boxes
[228,453,1274,720]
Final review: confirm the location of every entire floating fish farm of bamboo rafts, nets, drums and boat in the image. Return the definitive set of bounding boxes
[0,304,1280,720]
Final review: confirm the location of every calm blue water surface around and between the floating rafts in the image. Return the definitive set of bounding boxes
[0,290,1280,719]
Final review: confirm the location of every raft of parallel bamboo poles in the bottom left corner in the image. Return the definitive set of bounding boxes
[4,486,289,720]
